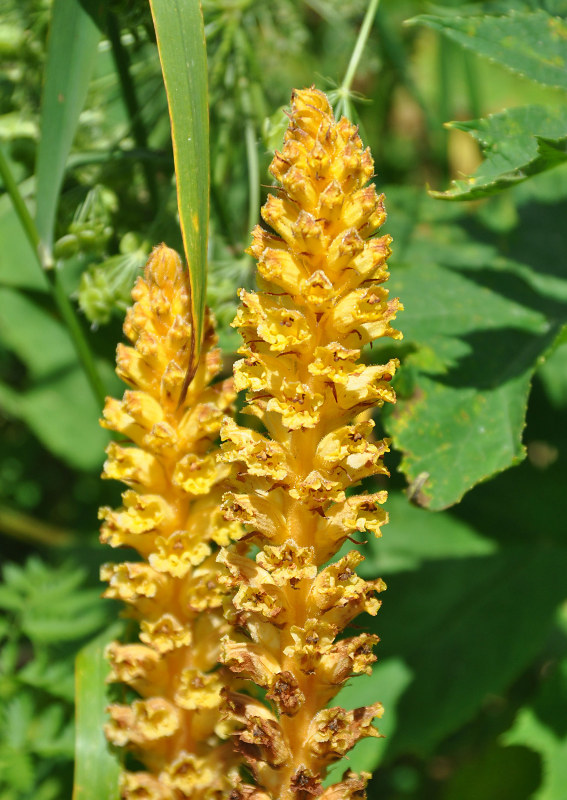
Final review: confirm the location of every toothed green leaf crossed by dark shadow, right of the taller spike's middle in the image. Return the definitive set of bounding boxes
[386,264,556,510]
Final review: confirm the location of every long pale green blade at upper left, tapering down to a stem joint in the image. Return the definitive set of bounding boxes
[36,0,101,264]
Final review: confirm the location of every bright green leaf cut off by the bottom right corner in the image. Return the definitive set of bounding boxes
[503,659,567,800]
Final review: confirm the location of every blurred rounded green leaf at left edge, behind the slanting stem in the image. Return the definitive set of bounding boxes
[0,288,108,470]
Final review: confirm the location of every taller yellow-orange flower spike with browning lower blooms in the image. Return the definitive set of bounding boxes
[219,89,401,800]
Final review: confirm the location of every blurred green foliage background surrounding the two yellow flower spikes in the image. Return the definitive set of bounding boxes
[0,0,567,800]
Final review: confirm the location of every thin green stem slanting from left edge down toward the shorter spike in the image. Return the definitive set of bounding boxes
[0,143,106,405]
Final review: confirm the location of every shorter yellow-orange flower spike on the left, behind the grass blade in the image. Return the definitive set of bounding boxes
[99,245,240,800]
